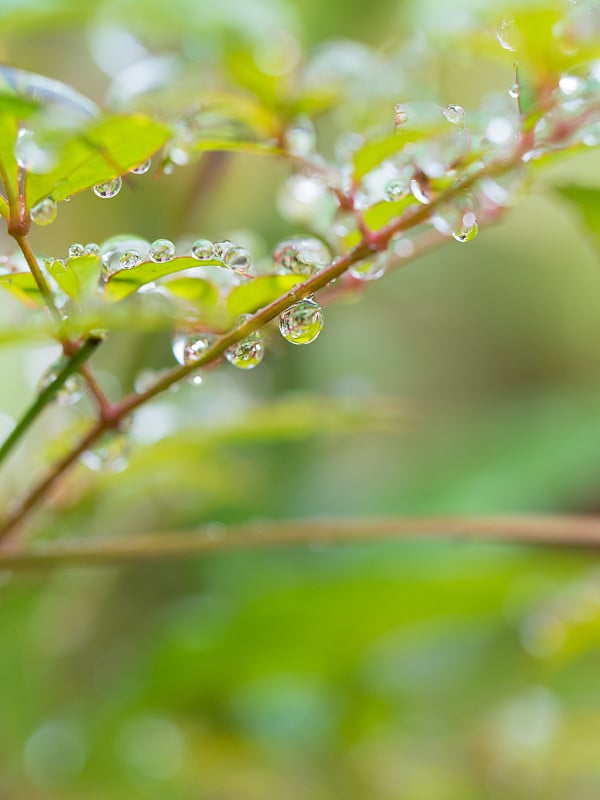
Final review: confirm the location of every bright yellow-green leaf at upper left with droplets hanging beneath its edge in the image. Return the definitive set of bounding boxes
[27,114,170,206]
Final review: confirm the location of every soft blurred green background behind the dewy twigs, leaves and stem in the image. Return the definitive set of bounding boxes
[0,0,600,800]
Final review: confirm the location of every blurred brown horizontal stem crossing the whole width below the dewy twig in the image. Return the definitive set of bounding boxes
[0,515,600,569]
